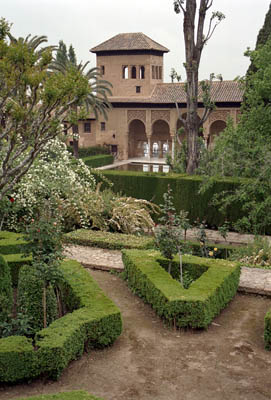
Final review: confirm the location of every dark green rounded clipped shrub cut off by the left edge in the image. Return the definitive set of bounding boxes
[0,255,13,324]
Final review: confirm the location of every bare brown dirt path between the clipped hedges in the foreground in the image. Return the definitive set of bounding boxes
[0,271,271,400]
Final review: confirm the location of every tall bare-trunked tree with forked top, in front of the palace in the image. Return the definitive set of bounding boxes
[174,0,225,174]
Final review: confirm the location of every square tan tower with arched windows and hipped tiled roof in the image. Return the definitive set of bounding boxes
[90,32,169,98]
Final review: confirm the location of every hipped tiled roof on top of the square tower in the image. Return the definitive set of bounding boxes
[90,32,169,53]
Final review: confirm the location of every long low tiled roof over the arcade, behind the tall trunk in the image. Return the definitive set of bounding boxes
[110,81,243,104]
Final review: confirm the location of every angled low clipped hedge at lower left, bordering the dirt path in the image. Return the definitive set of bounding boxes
[0,260,122,382]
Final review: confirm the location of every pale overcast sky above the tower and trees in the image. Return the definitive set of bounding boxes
[0,0,270,82]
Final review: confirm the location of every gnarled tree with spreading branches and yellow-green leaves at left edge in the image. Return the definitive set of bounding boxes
[0,19,99,200]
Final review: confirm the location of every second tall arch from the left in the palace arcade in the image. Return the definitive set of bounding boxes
[150,119,172,158]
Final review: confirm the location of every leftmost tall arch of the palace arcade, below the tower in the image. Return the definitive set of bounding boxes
[128,119,148,158]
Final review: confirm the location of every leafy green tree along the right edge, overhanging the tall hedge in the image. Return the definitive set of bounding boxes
[201,38,271,234]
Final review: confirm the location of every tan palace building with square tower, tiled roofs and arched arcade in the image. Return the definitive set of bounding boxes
[69,33,242,160]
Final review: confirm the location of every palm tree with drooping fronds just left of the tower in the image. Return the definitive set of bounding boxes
[51,41,112,158]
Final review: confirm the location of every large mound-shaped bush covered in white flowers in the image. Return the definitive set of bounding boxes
[1,138,96,230]
